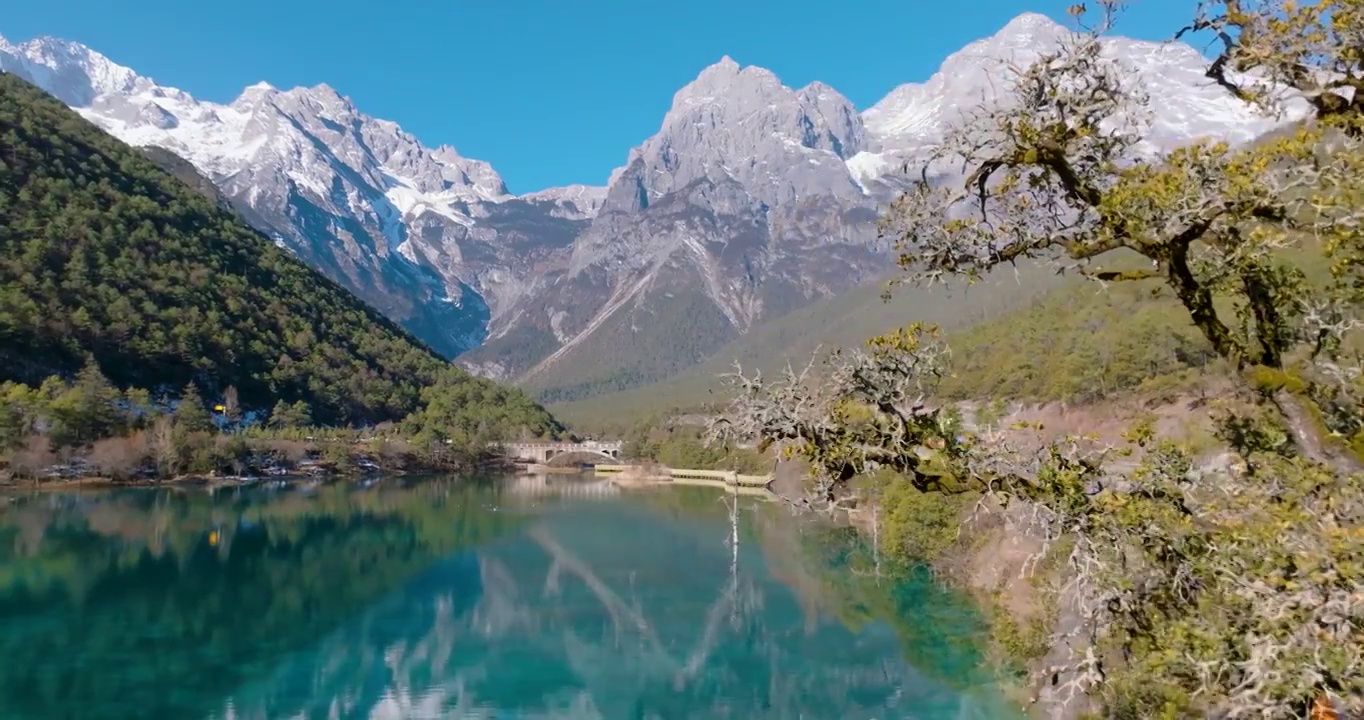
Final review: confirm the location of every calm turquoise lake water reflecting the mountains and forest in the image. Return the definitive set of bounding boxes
[0,479,1016,720]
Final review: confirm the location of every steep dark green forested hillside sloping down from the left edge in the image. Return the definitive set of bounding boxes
[0,74,557,431]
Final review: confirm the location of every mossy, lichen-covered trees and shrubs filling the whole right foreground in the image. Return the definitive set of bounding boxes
[712,0,1364,717]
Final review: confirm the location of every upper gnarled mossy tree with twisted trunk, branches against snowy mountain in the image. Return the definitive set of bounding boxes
[883,1,1364,468]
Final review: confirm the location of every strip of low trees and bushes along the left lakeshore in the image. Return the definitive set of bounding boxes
[0,365,562,480]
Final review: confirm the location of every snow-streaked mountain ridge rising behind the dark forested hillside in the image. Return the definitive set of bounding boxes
[0,32,602,356]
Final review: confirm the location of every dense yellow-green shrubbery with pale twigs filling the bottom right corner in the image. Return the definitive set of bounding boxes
[1071,432,1364,717]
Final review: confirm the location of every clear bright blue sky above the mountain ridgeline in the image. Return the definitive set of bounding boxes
[8,0,1194,192]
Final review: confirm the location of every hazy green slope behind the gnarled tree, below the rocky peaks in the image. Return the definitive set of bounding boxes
[551,240,1327,432]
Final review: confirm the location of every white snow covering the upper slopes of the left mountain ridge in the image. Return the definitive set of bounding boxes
[0,31,510,225]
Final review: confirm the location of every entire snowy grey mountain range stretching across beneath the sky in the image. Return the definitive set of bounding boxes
[0,14,1290,400]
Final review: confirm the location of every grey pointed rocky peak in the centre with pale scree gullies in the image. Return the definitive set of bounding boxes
[466,57,884,398]
